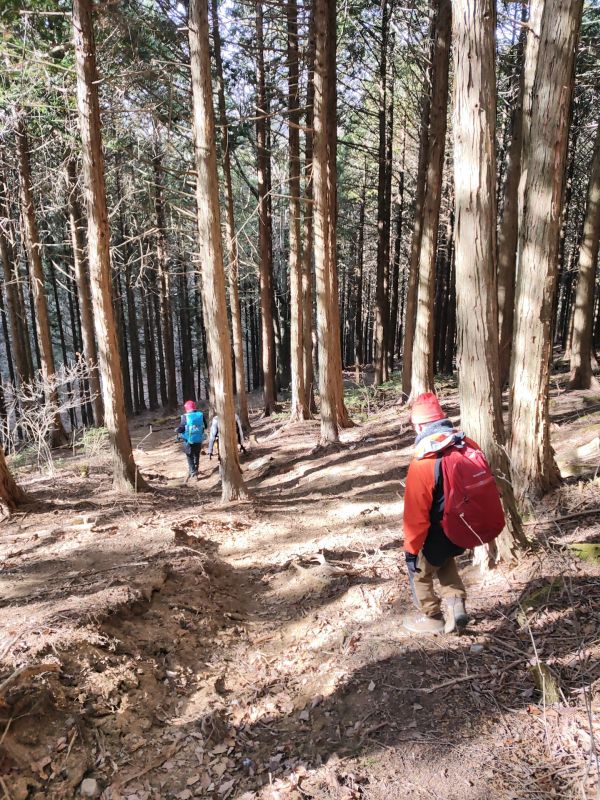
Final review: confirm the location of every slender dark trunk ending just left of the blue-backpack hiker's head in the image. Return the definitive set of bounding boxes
[152,153,177,411]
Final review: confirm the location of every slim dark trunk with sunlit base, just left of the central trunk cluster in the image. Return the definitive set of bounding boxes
[256,0,276,417]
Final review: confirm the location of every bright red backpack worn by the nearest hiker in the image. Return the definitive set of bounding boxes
[442,440,504,548]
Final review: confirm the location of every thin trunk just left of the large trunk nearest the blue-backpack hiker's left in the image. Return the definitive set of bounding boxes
[67,158,104,426]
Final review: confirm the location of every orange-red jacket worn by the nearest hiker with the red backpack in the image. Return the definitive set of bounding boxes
[403,429,479,555]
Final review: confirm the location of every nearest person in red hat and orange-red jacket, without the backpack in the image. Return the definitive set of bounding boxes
[403,392,472,633]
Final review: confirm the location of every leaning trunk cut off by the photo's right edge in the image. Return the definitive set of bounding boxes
[570,119,600,389]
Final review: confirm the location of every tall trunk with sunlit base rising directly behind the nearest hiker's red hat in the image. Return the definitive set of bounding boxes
[411,0,452,398]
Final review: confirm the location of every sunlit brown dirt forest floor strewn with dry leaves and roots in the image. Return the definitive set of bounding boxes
[0,377,600,800]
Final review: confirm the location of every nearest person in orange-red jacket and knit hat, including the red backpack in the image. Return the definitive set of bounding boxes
[403,392,504,633]
